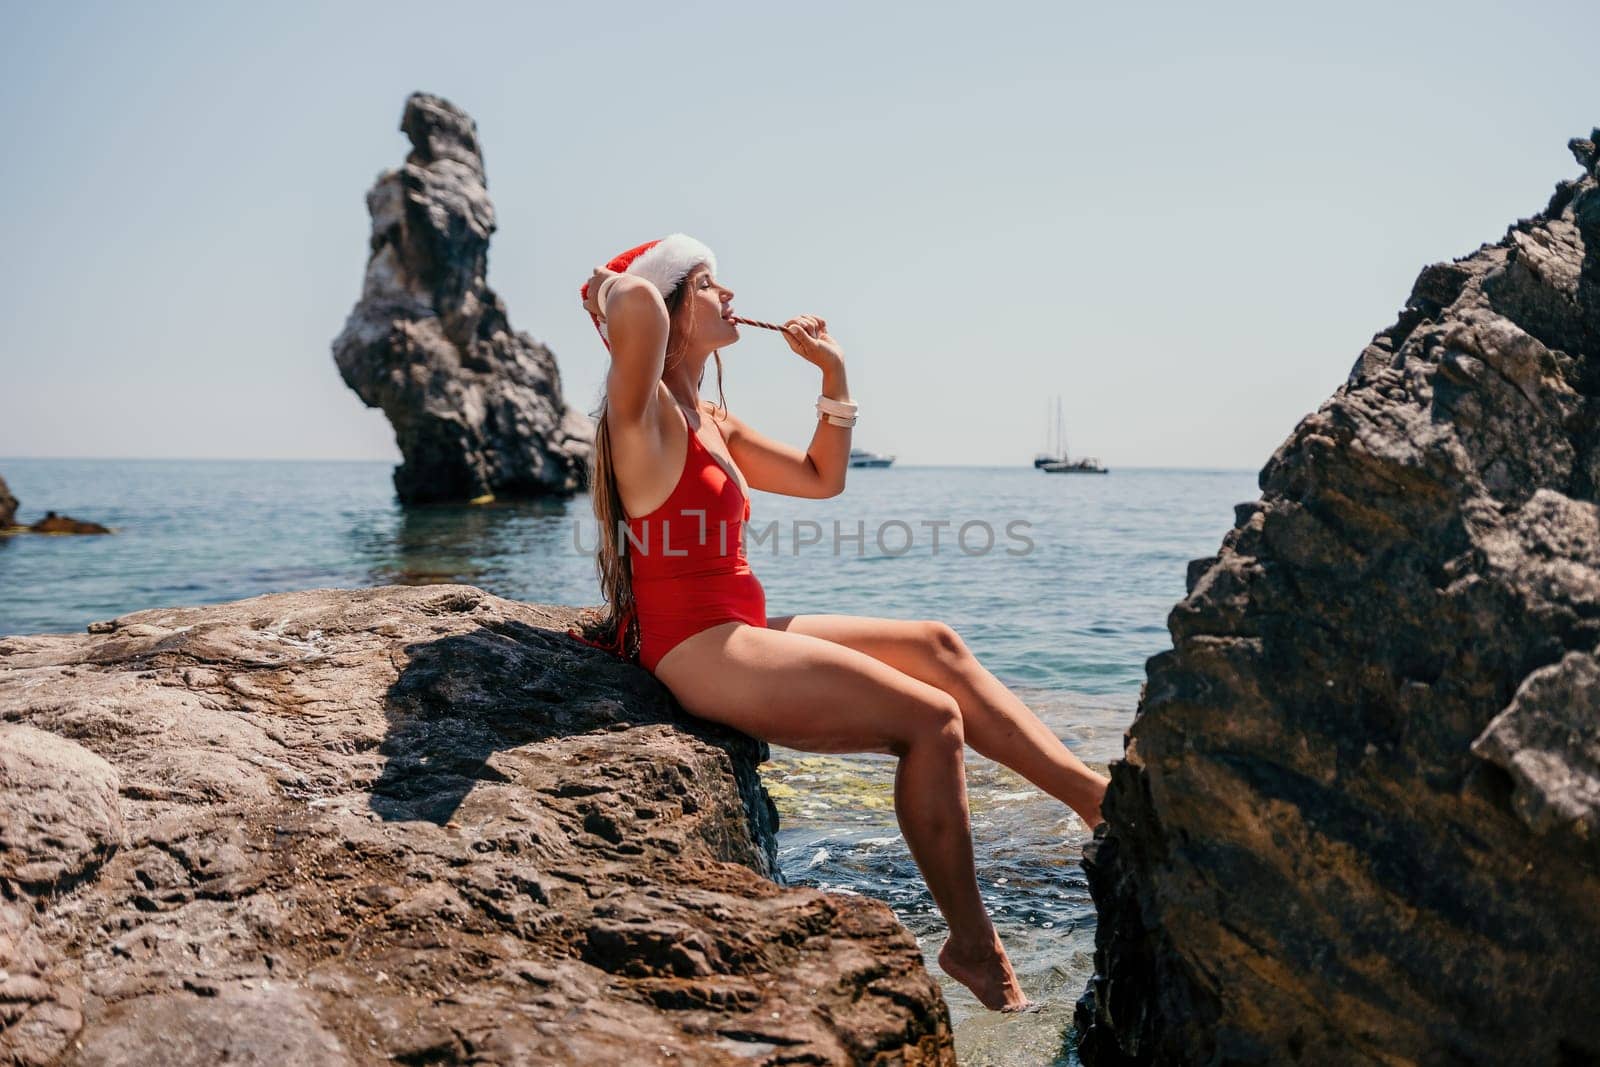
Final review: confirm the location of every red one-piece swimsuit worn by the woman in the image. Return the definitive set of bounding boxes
[570,405,766,672]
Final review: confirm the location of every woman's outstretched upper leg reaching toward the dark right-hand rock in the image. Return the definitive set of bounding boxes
[768,614,1109,829]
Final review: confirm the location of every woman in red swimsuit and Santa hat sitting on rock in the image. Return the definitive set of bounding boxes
[578,234,1106,1011]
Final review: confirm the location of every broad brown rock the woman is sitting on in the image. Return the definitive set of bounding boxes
[0,585,954,1064]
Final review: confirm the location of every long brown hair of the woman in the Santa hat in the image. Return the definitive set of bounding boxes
[579,267,728,664]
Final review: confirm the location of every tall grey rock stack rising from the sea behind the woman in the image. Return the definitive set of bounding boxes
[333,93,594,502]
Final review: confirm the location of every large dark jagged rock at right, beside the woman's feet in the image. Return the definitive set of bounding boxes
[1078,131,1600,1065]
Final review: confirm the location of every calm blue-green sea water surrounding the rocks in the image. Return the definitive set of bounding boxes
[0,459,1259,1064]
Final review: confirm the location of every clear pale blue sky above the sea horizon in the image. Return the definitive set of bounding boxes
[0,0,1600,469]
